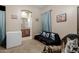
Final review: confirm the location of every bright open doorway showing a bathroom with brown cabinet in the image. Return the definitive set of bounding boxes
[21,10,32,38]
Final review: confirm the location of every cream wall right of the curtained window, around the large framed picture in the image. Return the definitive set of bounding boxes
[42,5,77,38]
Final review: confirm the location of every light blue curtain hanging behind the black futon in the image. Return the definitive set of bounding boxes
[41,11,52,32]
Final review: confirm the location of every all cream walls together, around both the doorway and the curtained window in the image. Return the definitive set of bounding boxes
[6,5,77,38]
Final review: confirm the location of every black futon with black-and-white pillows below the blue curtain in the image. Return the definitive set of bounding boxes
[34,31,61,45]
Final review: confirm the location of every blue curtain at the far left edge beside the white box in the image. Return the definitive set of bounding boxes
[0,10,6,44]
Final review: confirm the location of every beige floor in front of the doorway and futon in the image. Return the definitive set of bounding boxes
[0,39,44,53]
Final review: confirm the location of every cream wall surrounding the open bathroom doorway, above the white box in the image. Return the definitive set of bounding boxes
[6,5,41,36]
